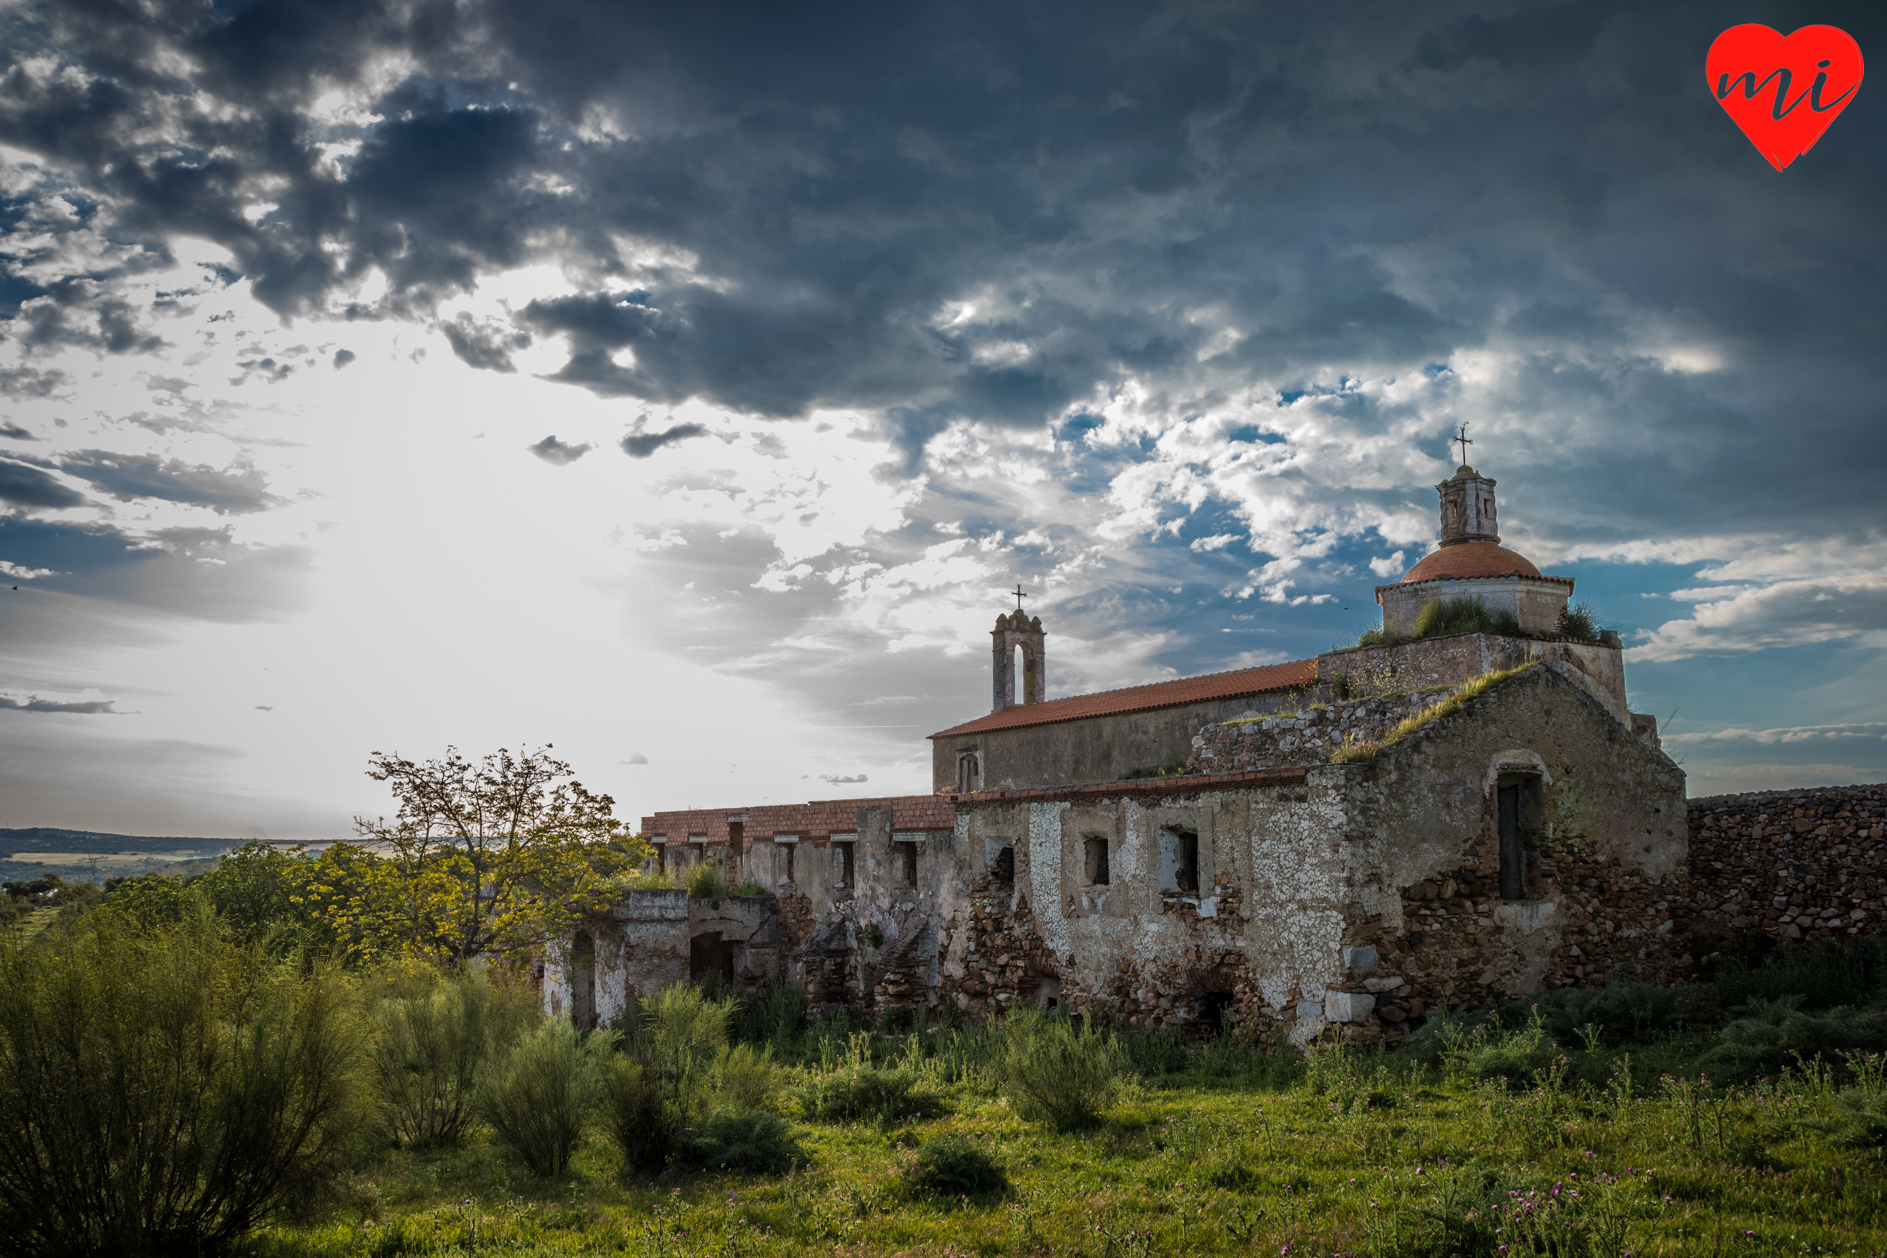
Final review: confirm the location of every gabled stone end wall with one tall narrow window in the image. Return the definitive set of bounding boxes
[1344,668,1689,1037]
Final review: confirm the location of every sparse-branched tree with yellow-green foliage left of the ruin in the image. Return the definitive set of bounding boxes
[304,747,649,966]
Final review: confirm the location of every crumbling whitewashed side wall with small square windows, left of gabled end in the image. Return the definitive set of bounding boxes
[944,768,1347,1041]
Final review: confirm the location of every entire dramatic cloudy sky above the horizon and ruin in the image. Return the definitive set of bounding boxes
[0,0,1887,837]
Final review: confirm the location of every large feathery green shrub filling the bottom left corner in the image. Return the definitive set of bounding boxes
[0,911,366,1258]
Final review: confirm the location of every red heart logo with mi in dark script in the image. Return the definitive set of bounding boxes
[1704,23,1861,170]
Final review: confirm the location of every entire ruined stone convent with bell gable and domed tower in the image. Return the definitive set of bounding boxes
[543,466,1689,1043]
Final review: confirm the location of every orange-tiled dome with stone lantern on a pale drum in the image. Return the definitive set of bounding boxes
[1376,464,1572,636]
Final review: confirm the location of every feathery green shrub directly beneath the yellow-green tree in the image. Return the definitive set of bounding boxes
[370,975,536,1147]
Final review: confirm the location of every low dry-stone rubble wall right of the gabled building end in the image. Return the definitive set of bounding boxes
[1689,783,1887,939]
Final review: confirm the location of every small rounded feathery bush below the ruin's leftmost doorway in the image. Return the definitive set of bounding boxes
[474,1020,615,1177]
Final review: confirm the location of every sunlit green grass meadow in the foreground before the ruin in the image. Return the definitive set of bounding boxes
[249,1034,1887,1258]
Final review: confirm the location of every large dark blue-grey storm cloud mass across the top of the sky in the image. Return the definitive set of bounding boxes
[0,0,1887,538]
